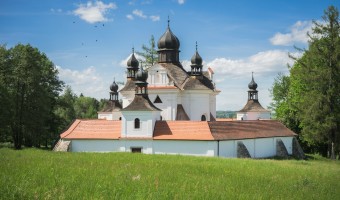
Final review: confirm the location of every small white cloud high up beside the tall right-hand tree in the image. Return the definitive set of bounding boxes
[270,21,313,46]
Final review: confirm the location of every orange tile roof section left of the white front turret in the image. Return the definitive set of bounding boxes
[60,119,122,139]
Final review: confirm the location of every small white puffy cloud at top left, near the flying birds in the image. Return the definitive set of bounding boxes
[73,1,117,23]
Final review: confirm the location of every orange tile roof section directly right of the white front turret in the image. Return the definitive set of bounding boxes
[154,121,214,140]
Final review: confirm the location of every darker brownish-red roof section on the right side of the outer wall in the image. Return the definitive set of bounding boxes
[208,120,296,140]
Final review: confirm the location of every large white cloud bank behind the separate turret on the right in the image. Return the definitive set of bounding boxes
[203,50,299,110]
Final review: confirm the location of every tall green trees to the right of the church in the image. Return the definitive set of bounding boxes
[271,6,340,159]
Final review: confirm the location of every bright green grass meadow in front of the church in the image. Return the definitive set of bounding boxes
[0,148,340,200]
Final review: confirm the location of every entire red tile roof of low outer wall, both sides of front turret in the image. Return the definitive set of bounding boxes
[60,119,296,140]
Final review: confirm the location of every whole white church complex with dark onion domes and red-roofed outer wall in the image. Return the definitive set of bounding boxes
[55,22,303,158]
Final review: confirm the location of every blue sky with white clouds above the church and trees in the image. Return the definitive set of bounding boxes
[0,0,340,110]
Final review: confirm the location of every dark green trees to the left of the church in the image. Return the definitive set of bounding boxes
[0,44,107,149]
